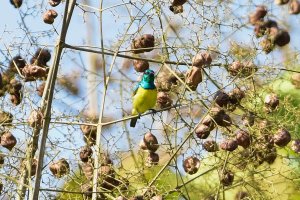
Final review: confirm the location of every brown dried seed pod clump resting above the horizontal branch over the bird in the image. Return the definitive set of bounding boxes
[131,34,154,54]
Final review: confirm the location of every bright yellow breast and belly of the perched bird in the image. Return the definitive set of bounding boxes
[132,87,157,115]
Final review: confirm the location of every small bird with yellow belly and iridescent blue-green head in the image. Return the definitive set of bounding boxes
[130,69,157,127]
